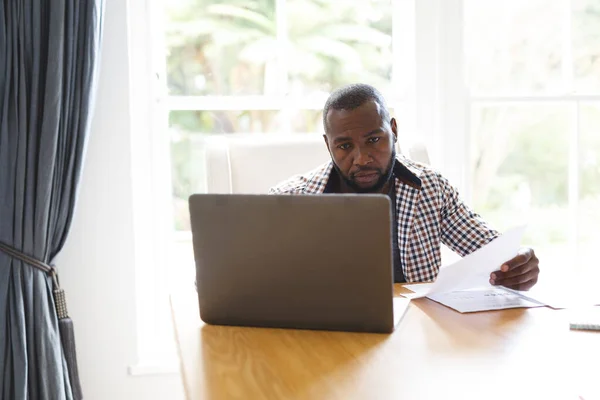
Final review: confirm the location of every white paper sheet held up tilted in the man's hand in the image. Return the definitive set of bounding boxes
[403,226,525,299]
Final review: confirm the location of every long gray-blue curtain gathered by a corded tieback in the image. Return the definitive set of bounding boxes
[0,0,103,400]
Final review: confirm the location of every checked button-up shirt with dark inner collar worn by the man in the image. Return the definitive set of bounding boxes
[269,155,498,282]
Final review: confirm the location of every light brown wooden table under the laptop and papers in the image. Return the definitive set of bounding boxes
[171,286,600,400]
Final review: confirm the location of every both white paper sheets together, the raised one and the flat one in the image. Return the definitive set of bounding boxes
[403,227,544,312]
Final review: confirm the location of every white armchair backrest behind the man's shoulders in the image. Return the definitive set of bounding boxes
[205,134,429,193]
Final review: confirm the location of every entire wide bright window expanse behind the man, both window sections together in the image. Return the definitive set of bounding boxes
[135,0,600,368]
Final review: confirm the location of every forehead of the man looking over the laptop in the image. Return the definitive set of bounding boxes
[327,100,383,135]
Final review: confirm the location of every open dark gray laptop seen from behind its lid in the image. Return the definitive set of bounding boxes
[189,194,408,333]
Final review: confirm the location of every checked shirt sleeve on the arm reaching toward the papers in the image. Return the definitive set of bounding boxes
[439,176,499,257]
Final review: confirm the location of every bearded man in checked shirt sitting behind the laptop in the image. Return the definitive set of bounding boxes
[270,84,539,290]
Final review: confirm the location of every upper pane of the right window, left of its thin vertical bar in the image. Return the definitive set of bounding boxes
[464,0,568,94]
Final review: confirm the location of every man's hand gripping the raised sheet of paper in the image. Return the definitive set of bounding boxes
[490,248,540,290]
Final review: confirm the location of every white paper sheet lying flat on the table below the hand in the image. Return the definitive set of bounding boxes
[427,287,543,313]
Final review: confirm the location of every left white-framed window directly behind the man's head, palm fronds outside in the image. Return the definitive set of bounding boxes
[159,0,415,290]
